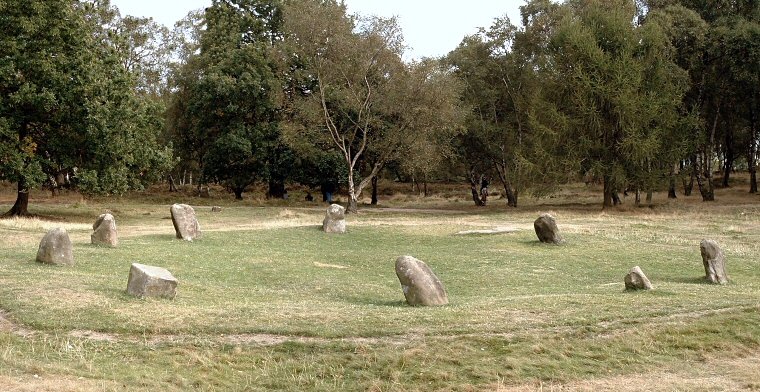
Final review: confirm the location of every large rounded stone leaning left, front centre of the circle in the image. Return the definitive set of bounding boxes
[396,256,449,306]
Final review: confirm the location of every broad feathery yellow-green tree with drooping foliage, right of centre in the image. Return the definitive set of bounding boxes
[547,0,687,207]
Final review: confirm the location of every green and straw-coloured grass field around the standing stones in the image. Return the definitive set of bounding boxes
[0,181,760,391]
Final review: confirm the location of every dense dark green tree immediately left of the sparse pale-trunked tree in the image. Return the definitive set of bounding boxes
[171,0,292,199]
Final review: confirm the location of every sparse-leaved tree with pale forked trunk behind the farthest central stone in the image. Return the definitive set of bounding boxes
[285,0,457,212]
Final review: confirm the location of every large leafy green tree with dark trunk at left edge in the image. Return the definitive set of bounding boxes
[0,0,171,215]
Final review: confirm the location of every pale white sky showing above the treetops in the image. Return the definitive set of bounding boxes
[111,0,525,59]
